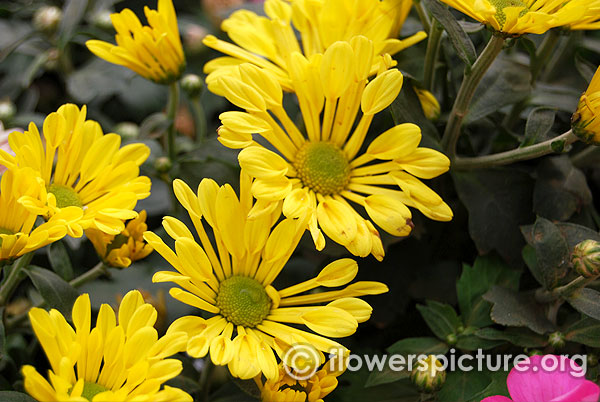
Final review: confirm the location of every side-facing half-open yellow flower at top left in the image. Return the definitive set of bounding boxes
[85,0,185,84]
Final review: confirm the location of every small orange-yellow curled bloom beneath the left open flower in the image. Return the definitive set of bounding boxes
[85,211,152,268]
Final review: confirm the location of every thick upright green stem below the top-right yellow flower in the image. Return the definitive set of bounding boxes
[442,35,505,159]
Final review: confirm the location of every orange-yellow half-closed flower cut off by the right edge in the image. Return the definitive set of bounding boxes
[571,67,600,145]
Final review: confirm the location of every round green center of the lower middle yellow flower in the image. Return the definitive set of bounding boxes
[216,276,271,328]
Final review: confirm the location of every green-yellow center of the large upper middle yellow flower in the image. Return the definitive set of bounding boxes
[294,142,351,195]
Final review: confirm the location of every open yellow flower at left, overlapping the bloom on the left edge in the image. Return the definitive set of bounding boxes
[0,104,150,237]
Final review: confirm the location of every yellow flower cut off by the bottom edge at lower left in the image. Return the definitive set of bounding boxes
[22,290,192,402]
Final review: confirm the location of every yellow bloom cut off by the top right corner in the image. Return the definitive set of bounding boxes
[442,0,600,35]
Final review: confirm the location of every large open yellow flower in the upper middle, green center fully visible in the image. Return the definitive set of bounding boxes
[207,36,452,260]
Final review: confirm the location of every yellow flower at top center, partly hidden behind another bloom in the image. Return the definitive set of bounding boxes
[204,0,427,91]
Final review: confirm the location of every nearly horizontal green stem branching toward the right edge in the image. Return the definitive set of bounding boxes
[452,130,578,170]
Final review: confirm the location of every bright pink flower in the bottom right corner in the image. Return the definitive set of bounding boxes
[481,355,600,402]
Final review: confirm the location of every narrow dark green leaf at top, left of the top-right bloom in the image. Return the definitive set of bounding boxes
[424,0,477,67]
